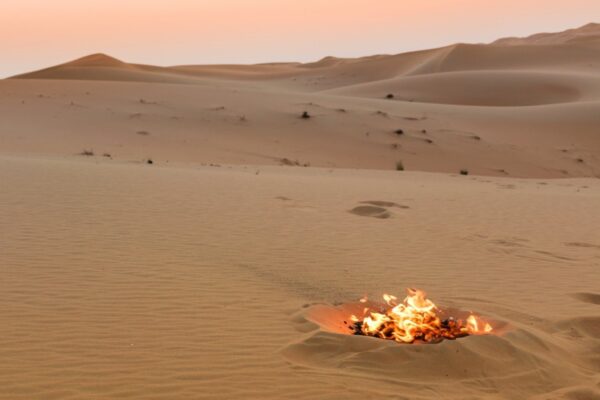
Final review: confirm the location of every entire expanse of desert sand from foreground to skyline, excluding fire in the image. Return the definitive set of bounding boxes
[0,24,600,400]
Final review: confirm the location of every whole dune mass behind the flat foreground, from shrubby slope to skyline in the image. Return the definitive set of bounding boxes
[0,24,600,177]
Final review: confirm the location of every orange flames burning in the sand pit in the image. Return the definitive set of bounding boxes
[350,289,493,343]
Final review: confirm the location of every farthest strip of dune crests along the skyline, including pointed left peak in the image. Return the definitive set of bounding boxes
[15,32,600,87]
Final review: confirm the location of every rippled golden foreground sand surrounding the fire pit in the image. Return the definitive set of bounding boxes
[0,157,600,400]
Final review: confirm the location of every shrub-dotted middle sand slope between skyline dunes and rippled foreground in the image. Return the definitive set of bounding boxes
[0,77,600,177]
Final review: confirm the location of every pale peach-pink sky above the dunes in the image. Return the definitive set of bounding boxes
[0,0,600,77]
